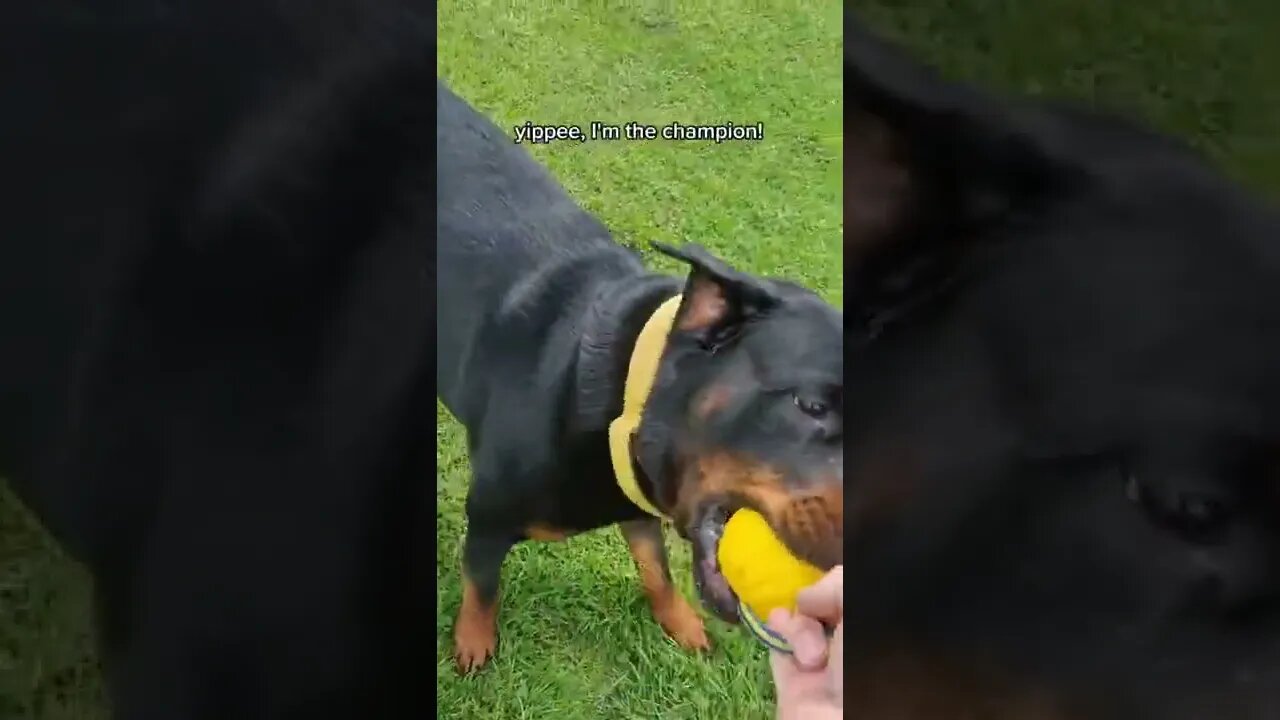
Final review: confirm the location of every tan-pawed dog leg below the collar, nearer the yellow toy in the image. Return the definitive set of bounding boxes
[618,519,710,650]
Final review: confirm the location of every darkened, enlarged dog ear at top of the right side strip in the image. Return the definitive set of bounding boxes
[845,12,1056,283]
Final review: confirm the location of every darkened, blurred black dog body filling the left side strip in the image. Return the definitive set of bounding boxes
[0,0,435,720]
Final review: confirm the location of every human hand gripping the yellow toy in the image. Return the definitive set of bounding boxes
[768,565,845,720]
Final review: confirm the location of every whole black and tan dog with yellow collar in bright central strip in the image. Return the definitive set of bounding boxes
[435,82,844,670]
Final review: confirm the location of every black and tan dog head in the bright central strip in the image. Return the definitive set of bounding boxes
[632,239,845,621]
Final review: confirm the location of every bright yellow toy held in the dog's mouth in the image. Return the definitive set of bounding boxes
[716,510,823,652]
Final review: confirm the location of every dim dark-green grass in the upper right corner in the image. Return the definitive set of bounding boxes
[858,0,1280,195]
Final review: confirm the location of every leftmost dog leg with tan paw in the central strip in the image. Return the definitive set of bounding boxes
[453,529,515,673]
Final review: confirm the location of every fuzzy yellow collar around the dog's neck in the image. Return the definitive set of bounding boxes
[609,295,681,518]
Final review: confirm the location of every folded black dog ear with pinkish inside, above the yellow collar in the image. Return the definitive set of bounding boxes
[653,242,780,348]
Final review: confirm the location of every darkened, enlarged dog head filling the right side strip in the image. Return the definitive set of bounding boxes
[844,14,1280,720]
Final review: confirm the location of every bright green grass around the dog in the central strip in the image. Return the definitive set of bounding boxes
[436,0,842,720]
